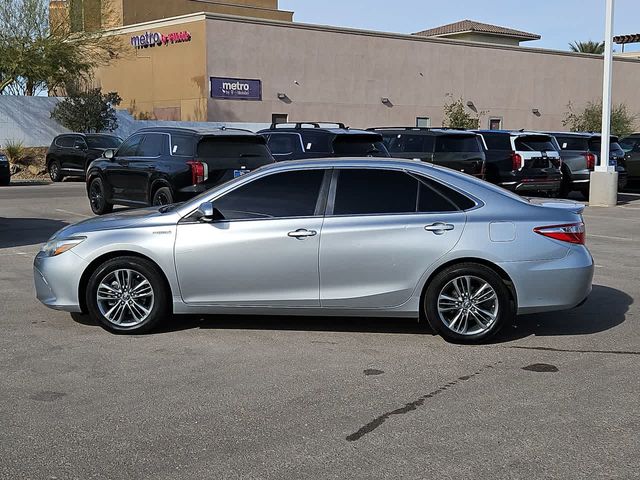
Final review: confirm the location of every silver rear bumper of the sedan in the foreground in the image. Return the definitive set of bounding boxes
[499,245,594,314]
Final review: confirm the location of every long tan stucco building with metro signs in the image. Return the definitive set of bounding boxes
[53,0,640,130]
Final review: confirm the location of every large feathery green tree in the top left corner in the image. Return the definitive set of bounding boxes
[0,0,123,95]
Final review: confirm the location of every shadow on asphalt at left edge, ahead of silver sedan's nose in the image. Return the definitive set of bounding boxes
[0,217,67,248]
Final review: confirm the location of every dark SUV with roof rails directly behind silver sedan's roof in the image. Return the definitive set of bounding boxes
[258,122,390,162]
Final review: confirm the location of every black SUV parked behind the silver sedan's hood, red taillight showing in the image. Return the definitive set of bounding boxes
[87,128,274,215]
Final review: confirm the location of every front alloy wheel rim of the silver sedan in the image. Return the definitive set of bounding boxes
[96,268,155,328]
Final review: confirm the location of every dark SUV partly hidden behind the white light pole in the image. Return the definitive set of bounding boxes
[549,132,627,198]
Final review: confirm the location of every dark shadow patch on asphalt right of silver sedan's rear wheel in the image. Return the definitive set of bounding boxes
[491,285,633,343]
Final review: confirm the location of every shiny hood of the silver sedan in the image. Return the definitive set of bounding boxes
[52,207,178,238]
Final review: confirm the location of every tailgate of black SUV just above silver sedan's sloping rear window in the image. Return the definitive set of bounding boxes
[433,133,485,177]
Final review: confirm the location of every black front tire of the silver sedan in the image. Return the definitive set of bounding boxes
[86,257,171,334]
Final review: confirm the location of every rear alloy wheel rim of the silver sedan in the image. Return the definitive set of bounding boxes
[438,275,500,336]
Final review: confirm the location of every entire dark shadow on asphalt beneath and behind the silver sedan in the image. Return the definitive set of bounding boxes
[72,285,633,344]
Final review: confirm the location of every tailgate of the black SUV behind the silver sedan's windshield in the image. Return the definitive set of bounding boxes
[196,135,274,187]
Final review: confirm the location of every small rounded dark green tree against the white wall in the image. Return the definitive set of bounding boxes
[51,88,122,133]
